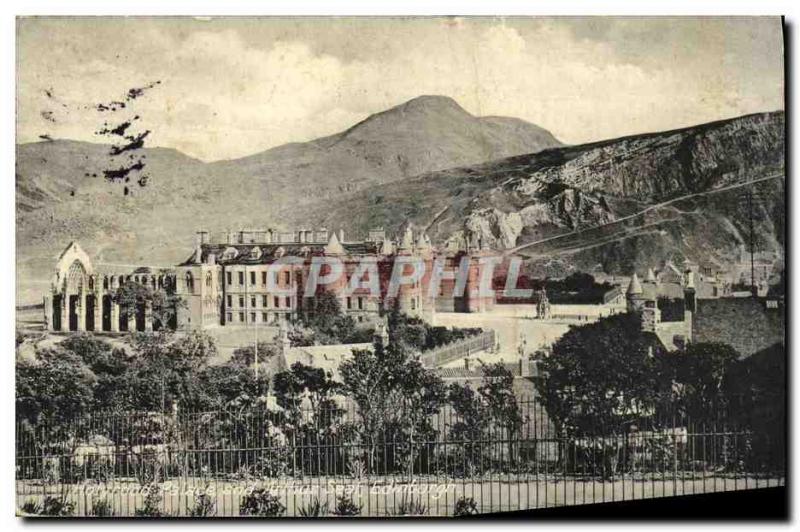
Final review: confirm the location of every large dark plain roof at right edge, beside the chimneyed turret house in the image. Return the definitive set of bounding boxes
[692,297,786,358]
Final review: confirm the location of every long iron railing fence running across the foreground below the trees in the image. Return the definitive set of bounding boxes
[16,399,785,516]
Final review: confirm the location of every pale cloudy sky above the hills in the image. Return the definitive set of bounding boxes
[17,17,783,161]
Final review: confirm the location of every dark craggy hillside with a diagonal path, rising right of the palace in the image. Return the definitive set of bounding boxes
[304,112,785,275]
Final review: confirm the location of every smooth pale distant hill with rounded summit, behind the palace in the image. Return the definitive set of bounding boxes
[16,96,560,301]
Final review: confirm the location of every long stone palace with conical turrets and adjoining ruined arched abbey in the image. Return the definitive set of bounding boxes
[44,227,494,332]
